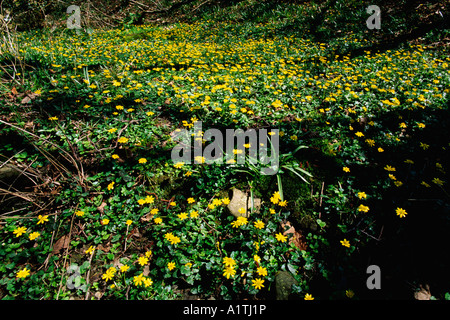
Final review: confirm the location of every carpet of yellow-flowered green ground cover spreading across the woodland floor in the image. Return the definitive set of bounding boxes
[0,1,450,299]
